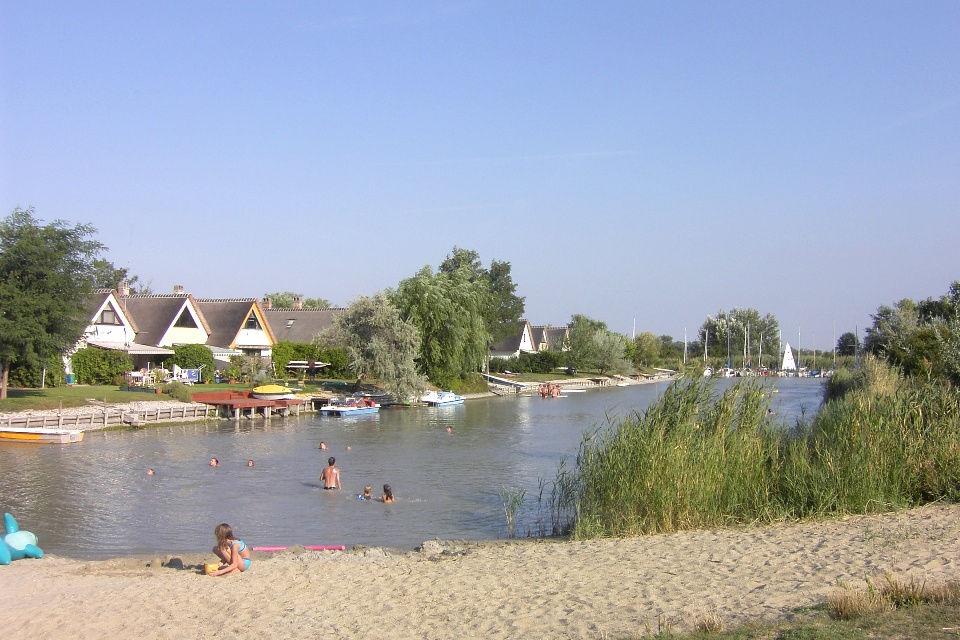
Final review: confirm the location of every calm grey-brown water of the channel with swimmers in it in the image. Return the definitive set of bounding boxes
[0,378,821,557]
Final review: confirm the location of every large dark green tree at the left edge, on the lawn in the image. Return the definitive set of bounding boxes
[0,207,103,400]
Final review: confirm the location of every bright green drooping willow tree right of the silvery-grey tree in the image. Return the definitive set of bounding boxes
[394,266,490,387]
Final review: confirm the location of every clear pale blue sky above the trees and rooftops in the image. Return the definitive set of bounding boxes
[0,0,960,349]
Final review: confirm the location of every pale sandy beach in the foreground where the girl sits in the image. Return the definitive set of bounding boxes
[0,505,960,639]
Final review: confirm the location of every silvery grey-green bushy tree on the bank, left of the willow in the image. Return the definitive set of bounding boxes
[326,292,425,401]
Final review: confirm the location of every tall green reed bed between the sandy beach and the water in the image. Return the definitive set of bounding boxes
[549,362,960,538]
